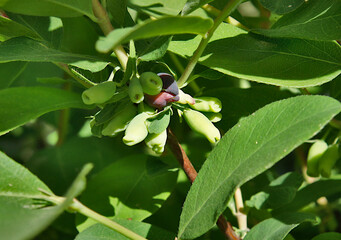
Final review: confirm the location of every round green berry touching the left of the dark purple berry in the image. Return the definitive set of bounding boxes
[140,72,163,95]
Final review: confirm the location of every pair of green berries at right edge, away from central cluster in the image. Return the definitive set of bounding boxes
[307,140,340,178]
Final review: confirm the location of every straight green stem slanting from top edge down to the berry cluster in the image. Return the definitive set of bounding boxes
[177,0,243,87]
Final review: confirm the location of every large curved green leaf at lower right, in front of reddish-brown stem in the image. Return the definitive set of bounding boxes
[178,96,341,239]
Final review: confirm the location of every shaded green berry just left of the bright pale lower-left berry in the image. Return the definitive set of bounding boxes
[102,103,137,136]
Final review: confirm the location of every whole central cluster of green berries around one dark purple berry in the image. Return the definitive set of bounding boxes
[82,72,222,154]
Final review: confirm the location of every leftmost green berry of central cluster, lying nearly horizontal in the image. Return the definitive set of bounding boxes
[82,81,116,105]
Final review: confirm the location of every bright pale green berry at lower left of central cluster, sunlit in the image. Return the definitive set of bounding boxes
[123,112,150,146]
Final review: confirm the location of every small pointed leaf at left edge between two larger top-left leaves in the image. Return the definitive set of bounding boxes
[0,16,40,40]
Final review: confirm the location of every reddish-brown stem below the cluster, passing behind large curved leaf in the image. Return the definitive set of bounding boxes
[167,129,240,240]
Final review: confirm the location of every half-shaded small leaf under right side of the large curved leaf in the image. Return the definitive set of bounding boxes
[246,172,303,209]
